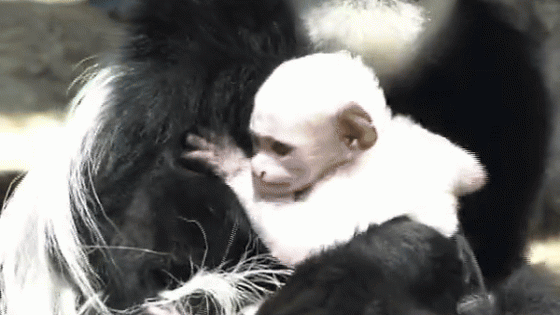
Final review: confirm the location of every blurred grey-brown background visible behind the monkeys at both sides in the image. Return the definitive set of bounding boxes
[0,0,560,271]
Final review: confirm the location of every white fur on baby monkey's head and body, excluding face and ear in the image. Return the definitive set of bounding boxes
[201,53,486,265]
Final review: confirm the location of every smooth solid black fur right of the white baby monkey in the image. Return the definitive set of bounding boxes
[381,0,550,282]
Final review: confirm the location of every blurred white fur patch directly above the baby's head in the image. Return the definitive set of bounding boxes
[292,0,456,77]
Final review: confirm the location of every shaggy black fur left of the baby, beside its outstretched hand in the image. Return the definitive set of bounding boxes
[82,0,295,309]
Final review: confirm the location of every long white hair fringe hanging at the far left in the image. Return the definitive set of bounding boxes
[0,68,118,315]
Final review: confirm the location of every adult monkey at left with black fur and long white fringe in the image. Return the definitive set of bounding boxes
[0,0,295,315]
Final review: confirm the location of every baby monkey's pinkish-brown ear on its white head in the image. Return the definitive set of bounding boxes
[336,102,377,150]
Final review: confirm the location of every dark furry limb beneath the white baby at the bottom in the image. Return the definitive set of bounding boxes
[258,218,463,315]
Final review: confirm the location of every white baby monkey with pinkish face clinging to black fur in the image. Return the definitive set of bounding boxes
[184,52,486,265]
